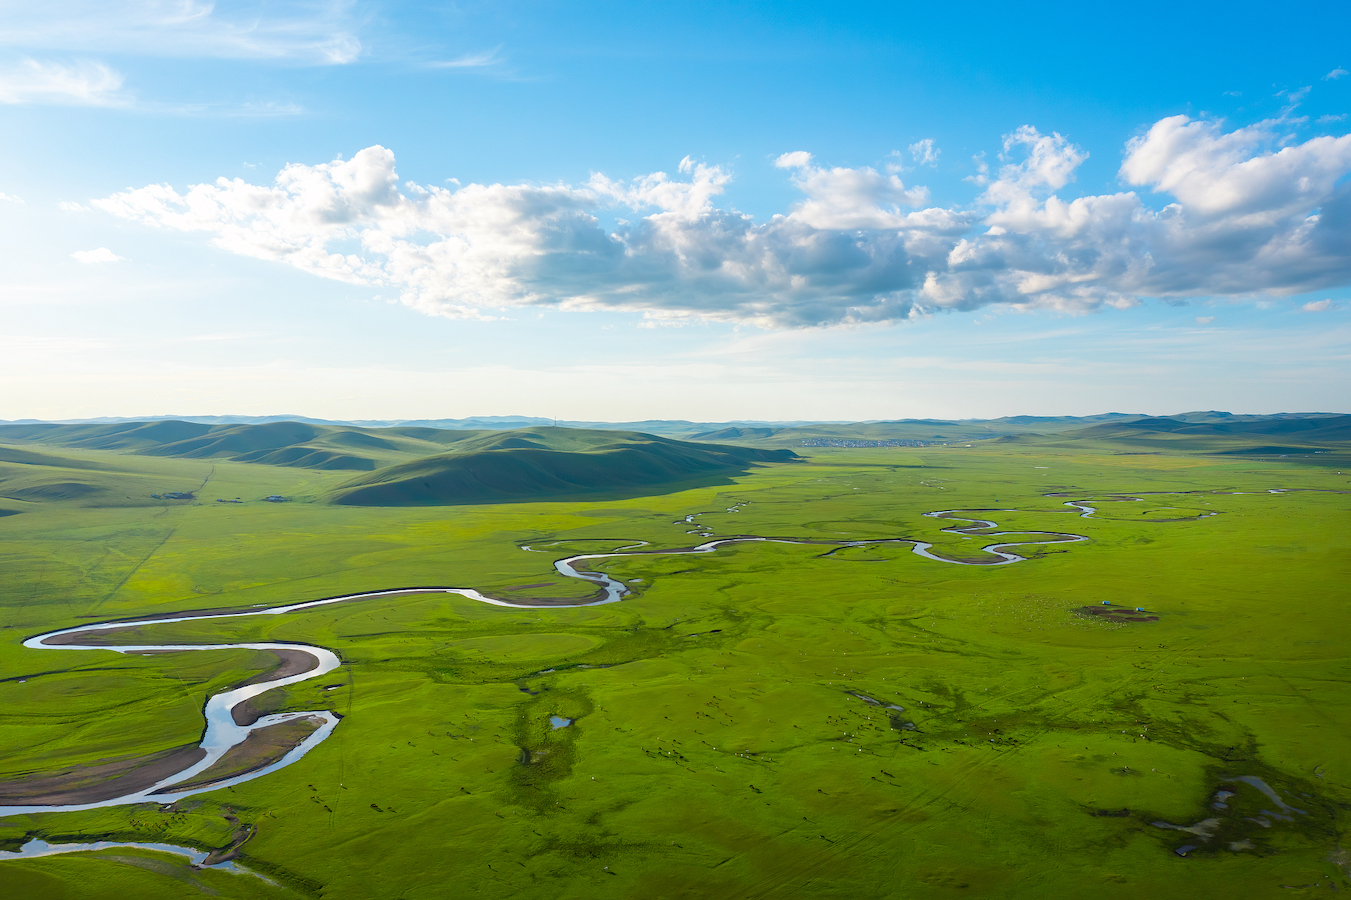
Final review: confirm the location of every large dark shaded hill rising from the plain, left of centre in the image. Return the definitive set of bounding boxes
[330,427,796,507]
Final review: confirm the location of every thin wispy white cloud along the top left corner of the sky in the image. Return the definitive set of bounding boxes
[0,0,361,65]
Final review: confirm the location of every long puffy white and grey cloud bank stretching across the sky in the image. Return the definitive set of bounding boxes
[93,116,1351,327]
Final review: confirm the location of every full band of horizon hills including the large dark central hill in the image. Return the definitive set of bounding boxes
[0,411,1351,515]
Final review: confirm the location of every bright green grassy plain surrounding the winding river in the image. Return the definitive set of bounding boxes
[0,442,1351,900]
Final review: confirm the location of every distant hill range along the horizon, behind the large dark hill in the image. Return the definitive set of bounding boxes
[0,411,1351,472]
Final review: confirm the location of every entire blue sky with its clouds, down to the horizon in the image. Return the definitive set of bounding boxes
[0,0,1351,422]
